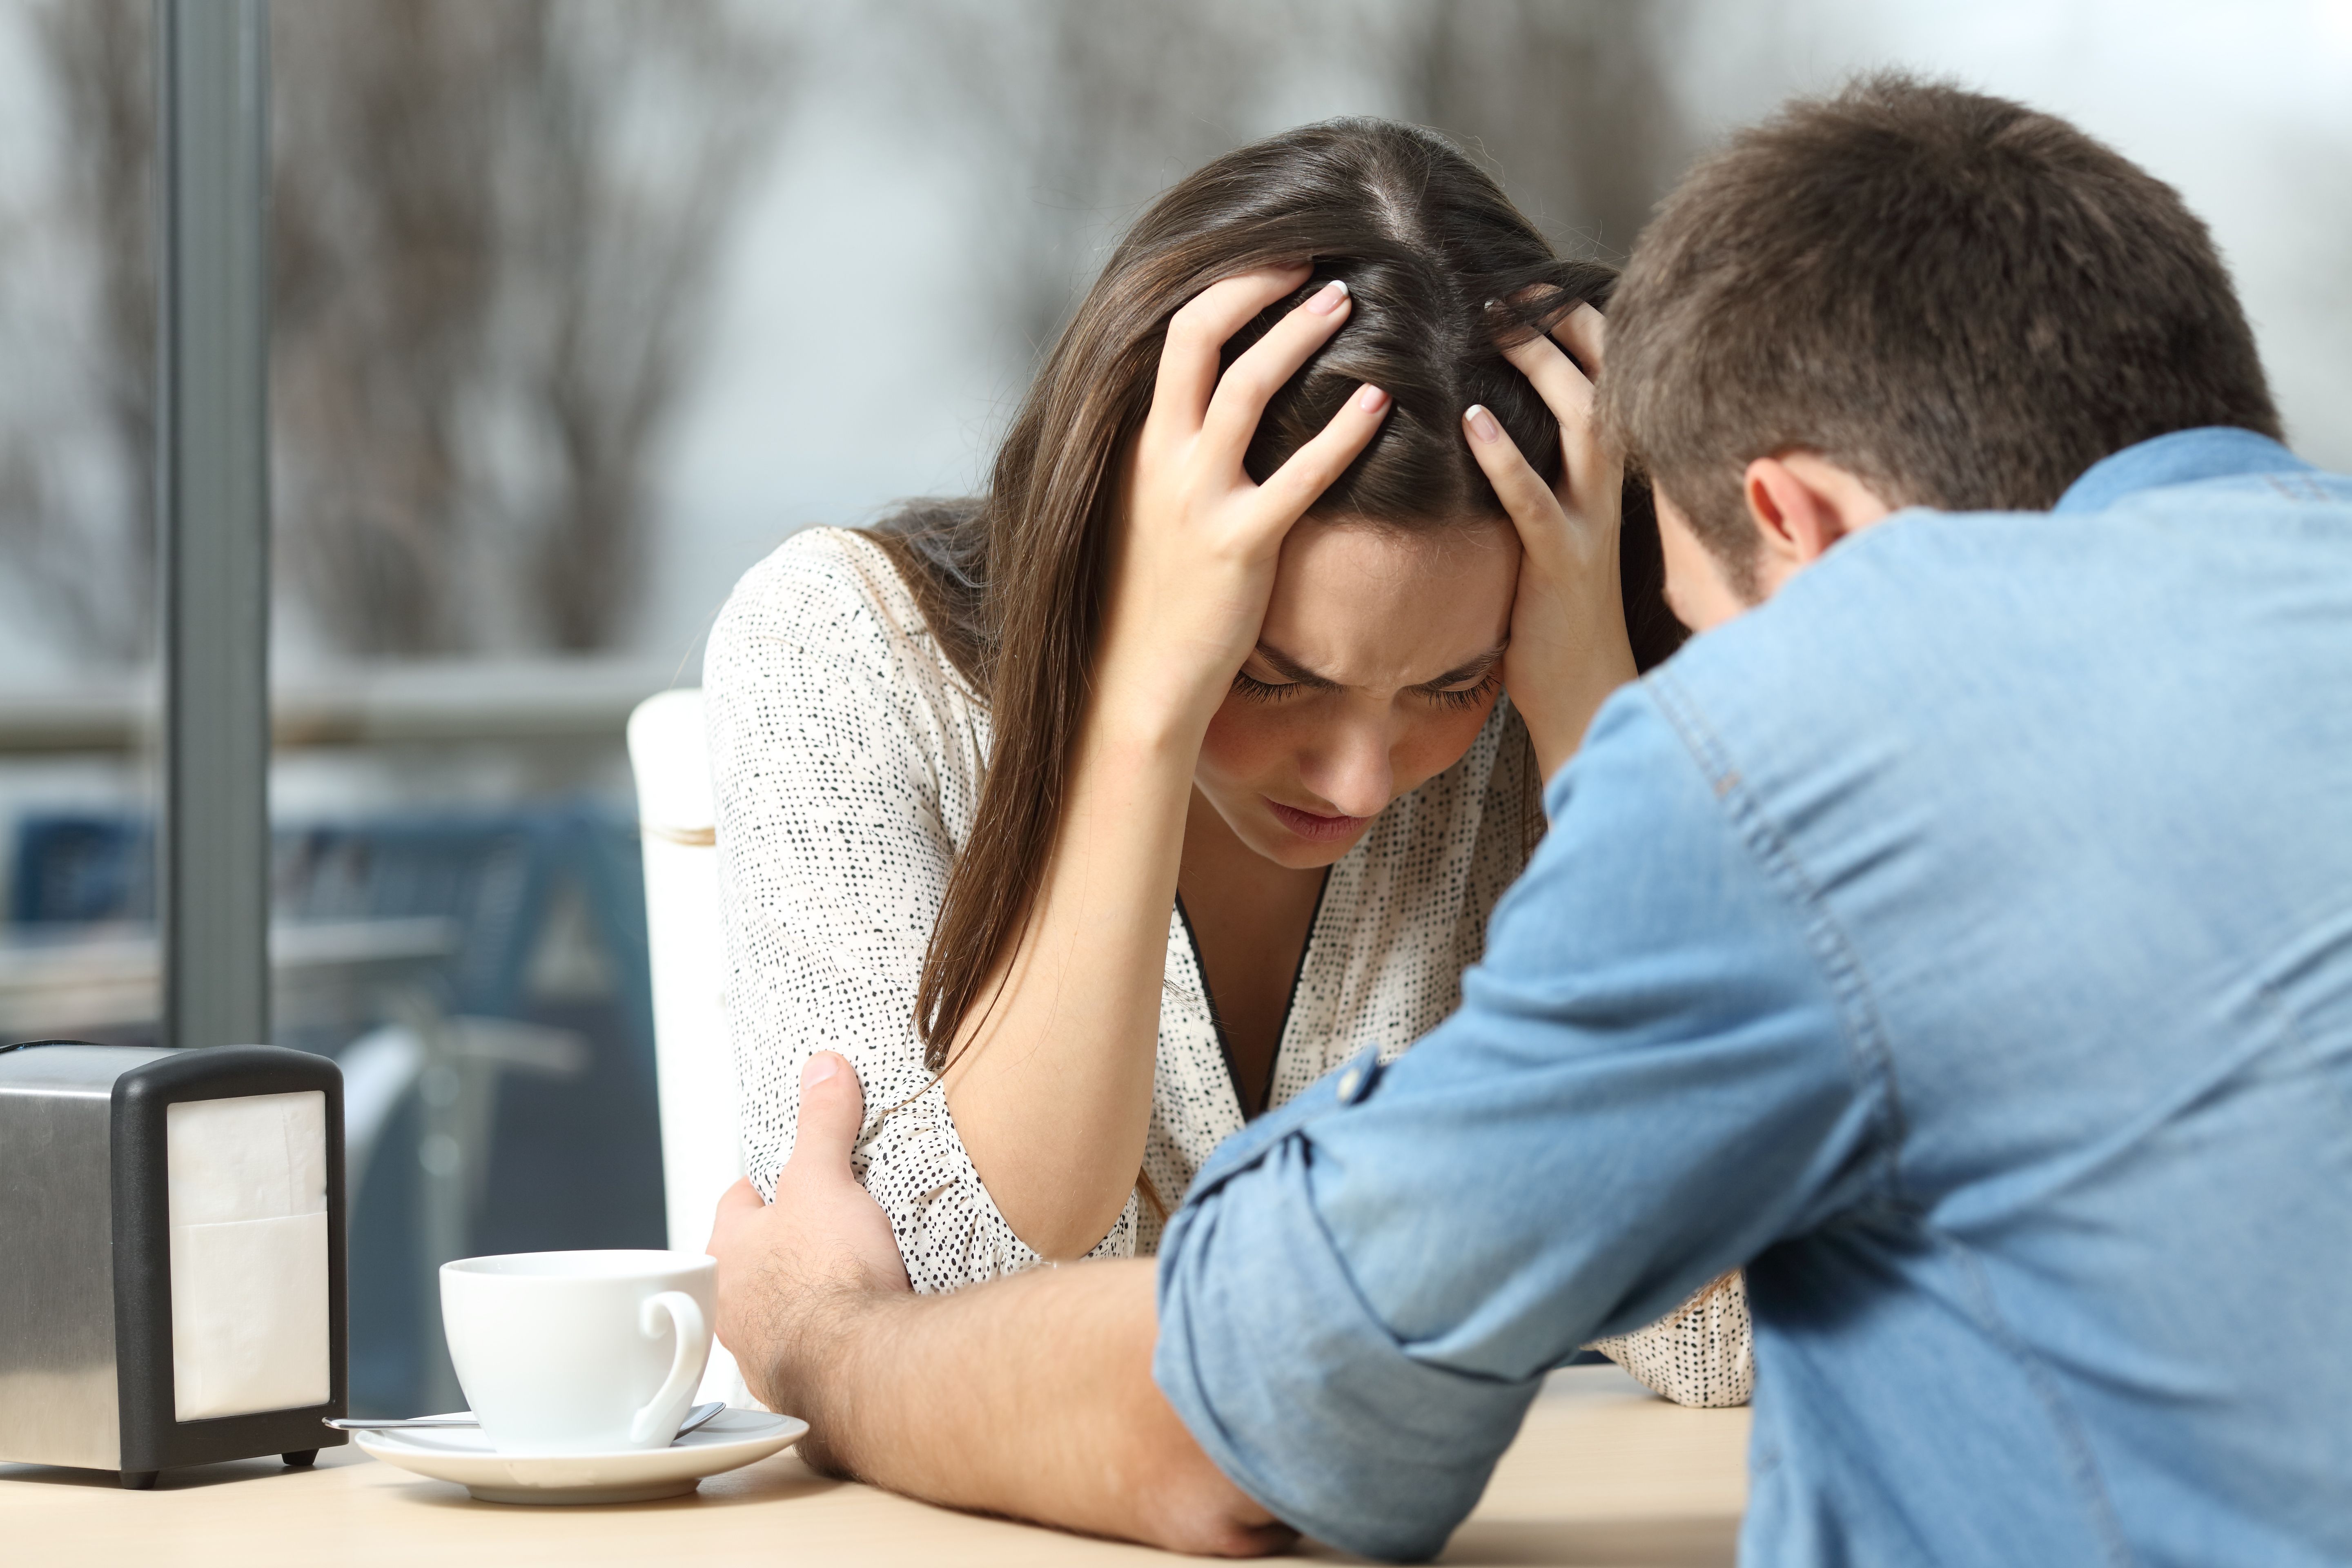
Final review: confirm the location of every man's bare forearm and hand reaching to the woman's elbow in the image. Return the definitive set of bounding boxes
[710,1051,1294,1556]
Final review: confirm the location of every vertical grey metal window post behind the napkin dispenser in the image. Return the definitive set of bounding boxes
[155,0,270,1046]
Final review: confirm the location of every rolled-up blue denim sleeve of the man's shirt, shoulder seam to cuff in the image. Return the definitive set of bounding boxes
[1152,689,1889,1559]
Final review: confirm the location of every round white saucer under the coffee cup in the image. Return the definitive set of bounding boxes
[350,1410,809,1502]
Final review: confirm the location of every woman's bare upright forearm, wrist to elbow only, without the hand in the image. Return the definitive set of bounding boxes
[946,693,1207,1258]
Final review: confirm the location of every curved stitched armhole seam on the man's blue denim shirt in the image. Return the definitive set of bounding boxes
[1642,668,1905,1206]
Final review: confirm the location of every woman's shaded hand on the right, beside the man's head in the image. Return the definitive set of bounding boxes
[1463,305,1635,778]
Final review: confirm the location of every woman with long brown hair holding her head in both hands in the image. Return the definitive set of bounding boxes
[708,120,1750,1403]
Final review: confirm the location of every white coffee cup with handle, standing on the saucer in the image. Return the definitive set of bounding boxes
[440,1251,717,1453]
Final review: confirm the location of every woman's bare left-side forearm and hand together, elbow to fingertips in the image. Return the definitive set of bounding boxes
[946,263,1388,1258]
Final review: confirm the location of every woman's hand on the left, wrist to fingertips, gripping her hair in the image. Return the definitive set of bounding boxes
[1096,266,1390,747]
